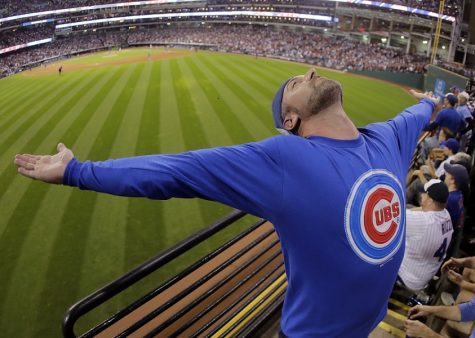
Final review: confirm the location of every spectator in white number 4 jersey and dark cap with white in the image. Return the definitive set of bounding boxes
[398,179,453,290]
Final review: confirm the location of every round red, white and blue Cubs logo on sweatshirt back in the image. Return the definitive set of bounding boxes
[345,170,406,264]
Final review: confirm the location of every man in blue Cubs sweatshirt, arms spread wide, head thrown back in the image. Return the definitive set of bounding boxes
[15,69,437,338]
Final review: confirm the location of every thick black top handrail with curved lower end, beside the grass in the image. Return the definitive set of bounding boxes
[62,210,246,338]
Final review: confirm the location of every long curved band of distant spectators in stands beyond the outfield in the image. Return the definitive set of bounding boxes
[0,25,427,75]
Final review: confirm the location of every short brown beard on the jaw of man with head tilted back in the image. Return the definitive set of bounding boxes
[309,79,342,115]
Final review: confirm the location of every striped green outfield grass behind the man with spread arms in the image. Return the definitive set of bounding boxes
[0,49,415,338]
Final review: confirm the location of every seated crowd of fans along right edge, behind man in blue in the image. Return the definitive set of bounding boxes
[402,86,475,337]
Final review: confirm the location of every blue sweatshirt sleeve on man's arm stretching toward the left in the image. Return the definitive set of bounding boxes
[63,137,283,220]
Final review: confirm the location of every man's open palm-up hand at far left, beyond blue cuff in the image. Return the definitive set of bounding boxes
[14,143,74,184]
